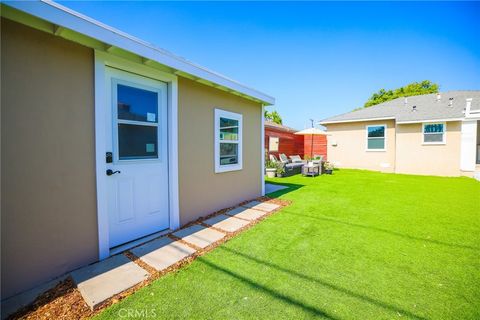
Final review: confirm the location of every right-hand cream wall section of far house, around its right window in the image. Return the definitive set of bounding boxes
[396,121,461,176]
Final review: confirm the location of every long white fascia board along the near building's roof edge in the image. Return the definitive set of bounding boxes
[7,0,275,105]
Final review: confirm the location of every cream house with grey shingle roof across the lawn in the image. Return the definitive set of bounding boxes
[320,91,480,176]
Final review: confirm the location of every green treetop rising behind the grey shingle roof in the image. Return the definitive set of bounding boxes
[363,80,440,108]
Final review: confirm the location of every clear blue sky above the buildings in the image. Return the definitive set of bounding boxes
[60,2,480,129]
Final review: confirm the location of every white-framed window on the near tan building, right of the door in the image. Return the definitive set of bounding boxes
[215,109,242,173]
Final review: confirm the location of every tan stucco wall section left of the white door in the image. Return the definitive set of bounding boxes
[1,19,98,298]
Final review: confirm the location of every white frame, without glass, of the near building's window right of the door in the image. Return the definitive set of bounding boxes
[213,109,243,173]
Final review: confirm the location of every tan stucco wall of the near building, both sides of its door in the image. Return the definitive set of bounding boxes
[1,19,263,299]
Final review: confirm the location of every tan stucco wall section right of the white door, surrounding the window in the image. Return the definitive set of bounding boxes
[178,78,263,225]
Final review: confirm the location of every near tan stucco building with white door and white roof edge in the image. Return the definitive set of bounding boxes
[1,1,274,299]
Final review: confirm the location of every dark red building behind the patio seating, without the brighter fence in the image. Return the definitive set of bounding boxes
[265,121,304,159]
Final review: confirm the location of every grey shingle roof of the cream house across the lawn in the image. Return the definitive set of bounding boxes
[320,90,480,124]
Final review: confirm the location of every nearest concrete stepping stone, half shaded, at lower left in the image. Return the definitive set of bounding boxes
[71,255,148,309]
